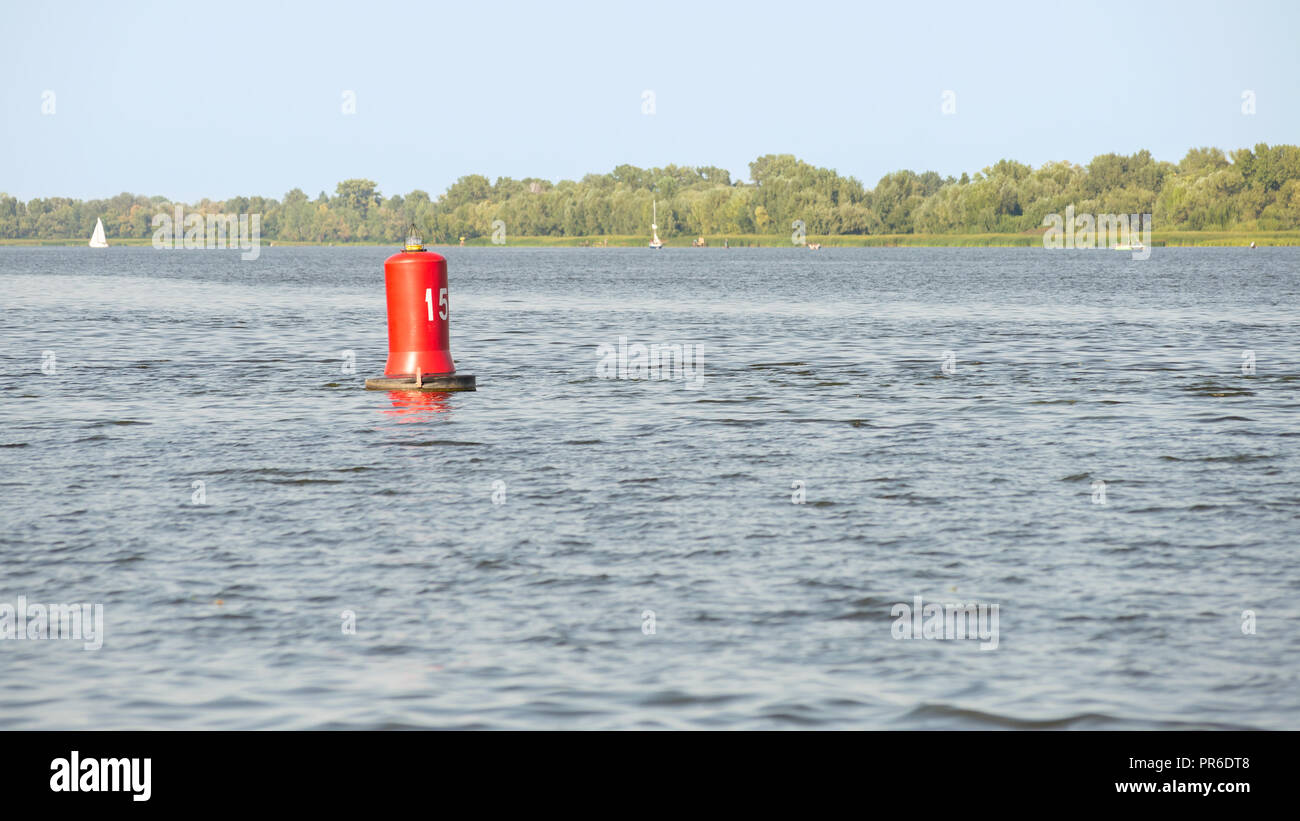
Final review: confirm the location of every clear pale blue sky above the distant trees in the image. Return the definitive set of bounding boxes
[0,0,1300,201]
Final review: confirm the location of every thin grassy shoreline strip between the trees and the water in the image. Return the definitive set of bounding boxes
[0,230,1300,248]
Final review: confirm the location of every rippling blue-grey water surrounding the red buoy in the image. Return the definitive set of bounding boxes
[0,248,1300,730]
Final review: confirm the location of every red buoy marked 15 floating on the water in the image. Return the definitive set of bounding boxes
[365,226,475,391]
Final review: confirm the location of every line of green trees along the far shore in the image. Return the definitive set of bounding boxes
[0,143,1300,243]
